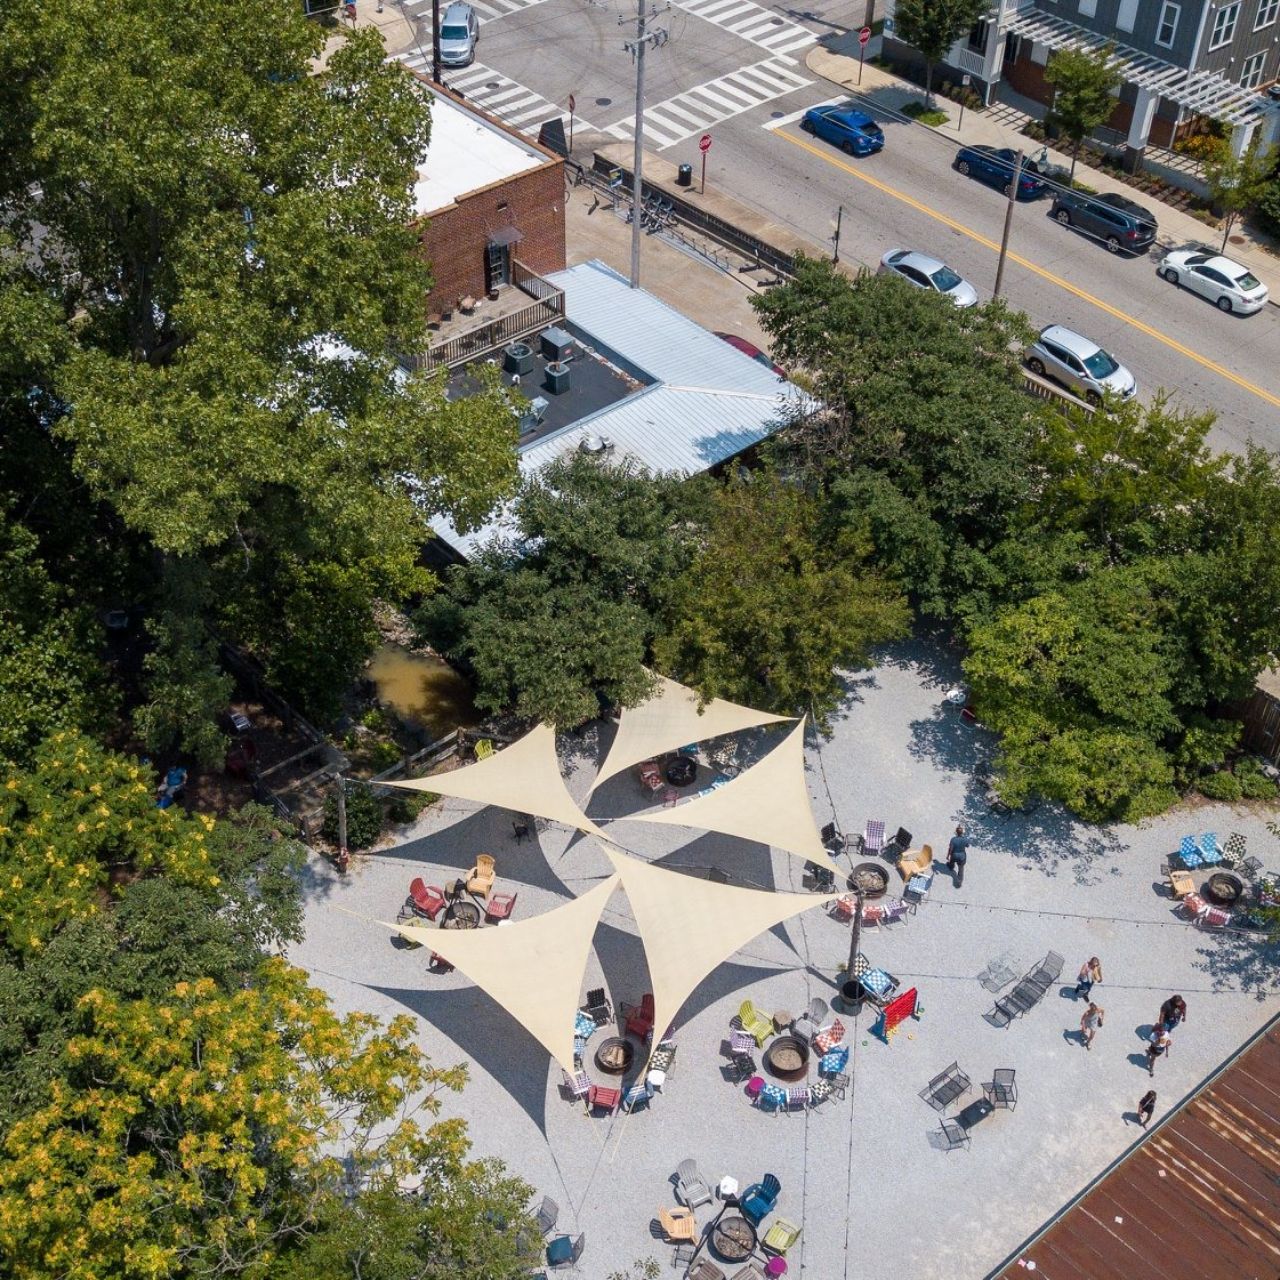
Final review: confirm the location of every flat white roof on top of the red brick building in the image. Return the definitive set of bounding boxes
[413,93,553,216]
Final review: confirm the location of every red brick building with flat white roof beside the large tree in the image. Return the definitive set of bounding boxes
[413,84,564,315]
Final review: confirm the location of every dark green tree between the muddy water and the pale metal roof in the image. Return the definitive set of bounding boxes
[417,454,707,728]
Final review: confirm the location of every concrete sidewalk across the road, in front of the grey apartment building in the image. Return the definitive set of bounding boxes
[805,35,1280,306]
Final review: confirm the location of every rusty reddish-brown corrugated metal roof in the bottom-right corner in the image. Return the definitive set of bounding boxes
[992,1019,1280,1280]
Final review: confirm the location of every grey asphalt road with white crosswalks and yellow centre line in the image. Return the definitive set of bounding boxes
[428,0,1280,451]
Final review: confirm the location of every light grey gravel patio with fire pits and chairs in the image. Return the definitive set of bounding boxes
[291,643,1280,1280]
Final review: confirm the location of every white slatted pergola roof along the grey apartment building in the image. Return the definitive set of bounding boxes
[1005,9,1267,124]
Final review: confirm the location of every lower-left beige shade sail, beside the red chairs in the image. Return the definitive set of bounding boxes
[379,876,618,1074]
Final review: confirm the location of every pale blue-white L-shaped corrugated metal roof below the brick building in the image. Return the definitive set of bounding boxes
[433,261,815,556]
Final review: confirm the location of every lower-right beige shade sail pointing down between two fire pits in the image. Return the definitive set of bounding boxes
[605,849,838,1049]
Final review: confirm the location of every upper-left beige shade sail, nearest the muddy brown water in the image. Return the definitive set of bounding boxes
[379,724,604,844]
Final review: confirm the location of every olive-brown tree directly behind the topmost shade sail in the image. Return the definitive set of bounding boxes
[654,472,910,723]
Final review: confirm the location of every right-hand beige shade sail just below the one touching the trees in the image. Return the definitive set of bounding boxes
[628,719,840,872]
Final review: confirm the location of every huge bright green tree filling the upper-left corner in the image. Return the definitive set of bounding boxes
[0,0,515,748]
